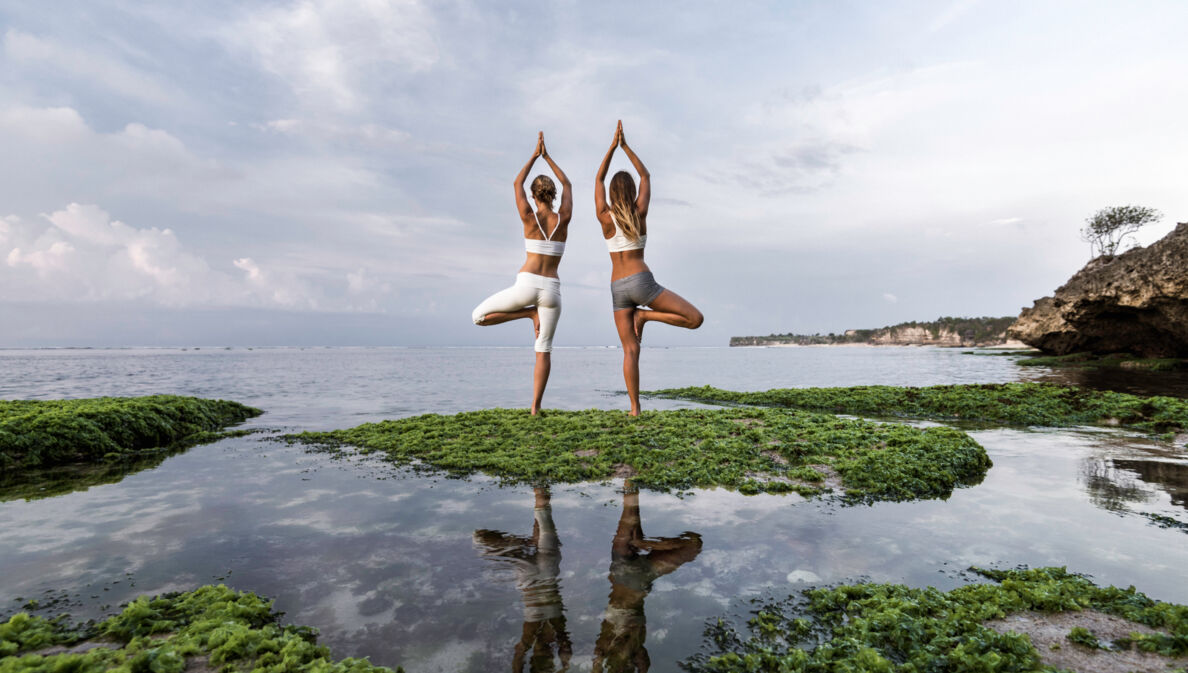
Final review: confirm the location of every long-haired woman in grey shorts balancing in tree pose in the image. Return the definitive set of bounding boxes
[594,121,703,416]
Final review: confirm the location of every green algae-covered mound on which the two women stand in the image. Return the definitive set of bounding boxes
[282,408,991,501]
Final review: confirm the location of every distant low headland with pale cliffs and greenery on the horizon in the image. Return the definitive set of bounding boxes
[731,316,1015,346]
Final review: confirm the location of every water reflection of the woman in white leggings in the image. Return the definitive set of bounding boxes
[474,486,574,673]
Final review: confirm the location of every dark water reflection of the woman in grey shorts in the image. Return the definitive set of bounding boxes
[594,482,701,673]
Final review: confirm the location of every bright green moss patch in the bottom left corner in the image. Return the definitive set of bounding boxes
[0,585,399,673]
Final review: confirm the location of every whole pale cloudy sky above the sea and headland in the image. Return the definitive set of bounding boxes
[0,0,1188,347]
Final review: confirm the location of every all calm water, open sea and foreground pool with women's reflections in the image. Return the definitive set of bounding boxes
[0,348,1188,673]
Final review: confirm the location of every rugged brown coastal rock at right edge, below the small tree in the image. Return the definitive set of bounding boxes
[1006,222,1188,358]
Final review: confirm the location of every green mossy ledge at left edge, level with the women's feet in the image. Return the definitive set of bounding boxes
[0,395,263,471]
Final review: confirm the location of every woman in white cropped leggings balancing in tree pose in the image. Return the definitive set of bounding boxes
[472,133,574,415]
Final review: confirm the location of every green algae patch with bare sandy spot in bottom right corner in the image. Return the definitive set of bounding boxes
[682,568,1188,673]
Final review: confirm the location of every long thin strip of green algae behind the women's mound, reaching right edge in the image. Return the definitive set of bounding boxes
[646,383,1188,433]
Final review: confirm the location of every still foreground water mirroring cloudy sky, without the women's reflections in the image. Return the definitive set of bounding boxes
[0,429,1188,671]
